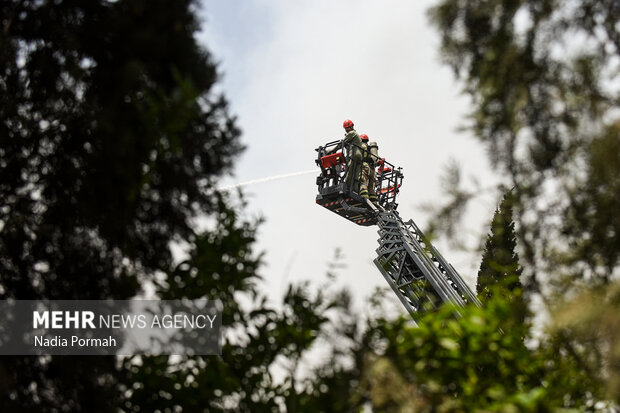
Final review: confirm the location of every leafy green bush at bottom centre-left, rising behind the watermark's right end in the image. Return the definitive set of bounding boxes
[118,230,368,412]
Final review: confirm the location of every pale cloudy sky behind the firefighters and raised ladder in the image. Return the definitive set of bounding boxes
[198,0,497,308]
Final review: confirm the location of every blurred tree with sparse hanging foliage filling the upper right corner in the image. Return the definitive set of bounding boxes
[430,0,620,293]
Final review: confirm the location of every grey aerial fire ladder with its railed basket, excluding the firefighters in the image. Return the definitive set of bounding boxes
[316,141,481,320]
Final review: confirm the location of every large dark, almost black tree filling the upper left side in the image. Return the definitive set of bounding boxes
[0,0,242,412]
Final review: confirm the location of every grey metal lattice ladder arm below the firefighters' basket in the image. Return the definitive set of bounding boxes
[374,210,481,320]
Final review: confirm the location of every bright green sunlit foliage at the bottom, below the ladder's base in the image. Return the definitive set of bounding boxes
[365,297,599,412]
